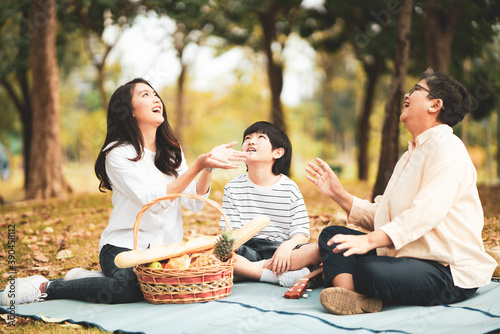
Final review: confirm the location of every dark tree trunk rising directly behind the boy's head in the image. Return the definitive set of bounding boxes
[259,9,286,133]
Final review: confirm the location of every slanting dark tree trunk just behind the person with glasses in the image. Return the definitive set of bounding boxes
[372,0,413,198]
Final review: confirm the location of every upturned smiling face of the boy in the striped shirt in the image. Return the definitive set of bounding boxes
[241,132,284,165]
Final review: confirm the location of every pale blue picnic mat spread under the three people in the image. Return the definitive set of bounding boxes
[0,281,500,334]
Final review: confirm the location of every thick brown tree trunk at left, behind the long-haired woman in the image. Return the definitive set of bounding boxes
[26,0,69,199]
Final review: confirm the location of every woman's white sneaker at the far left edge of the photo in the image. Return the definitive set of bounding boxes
[2,275,49,306]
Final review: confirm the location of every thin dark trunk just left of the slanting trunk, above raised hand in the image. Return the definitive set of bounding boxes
[358,60,382,180]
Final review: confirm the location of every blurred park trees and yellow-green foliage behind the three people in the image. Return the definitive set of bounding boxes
[0,0,500,201]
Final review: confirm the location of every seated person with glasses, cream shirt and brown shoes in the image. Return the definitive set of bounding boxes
[306,70,496,314]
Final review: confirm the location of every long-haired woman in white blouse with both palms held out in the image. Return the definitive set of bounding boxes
[2,79,247,305]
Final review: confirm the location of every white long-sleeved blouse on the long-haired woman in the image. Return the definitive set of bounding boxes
[99,144,208,250]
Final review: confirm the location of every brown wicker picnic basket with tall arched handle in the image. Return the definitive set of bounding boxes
[134,194,235,304]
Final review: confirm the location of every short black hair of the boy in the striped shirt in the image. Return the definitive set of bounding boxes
[243,121,292,175]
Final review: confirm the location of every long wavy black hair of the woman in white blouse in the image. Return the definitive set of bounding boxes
[94,78,182,192]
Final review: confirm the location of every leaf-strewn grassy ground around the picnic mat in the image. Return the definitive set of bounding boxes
[0,177,500,333]
